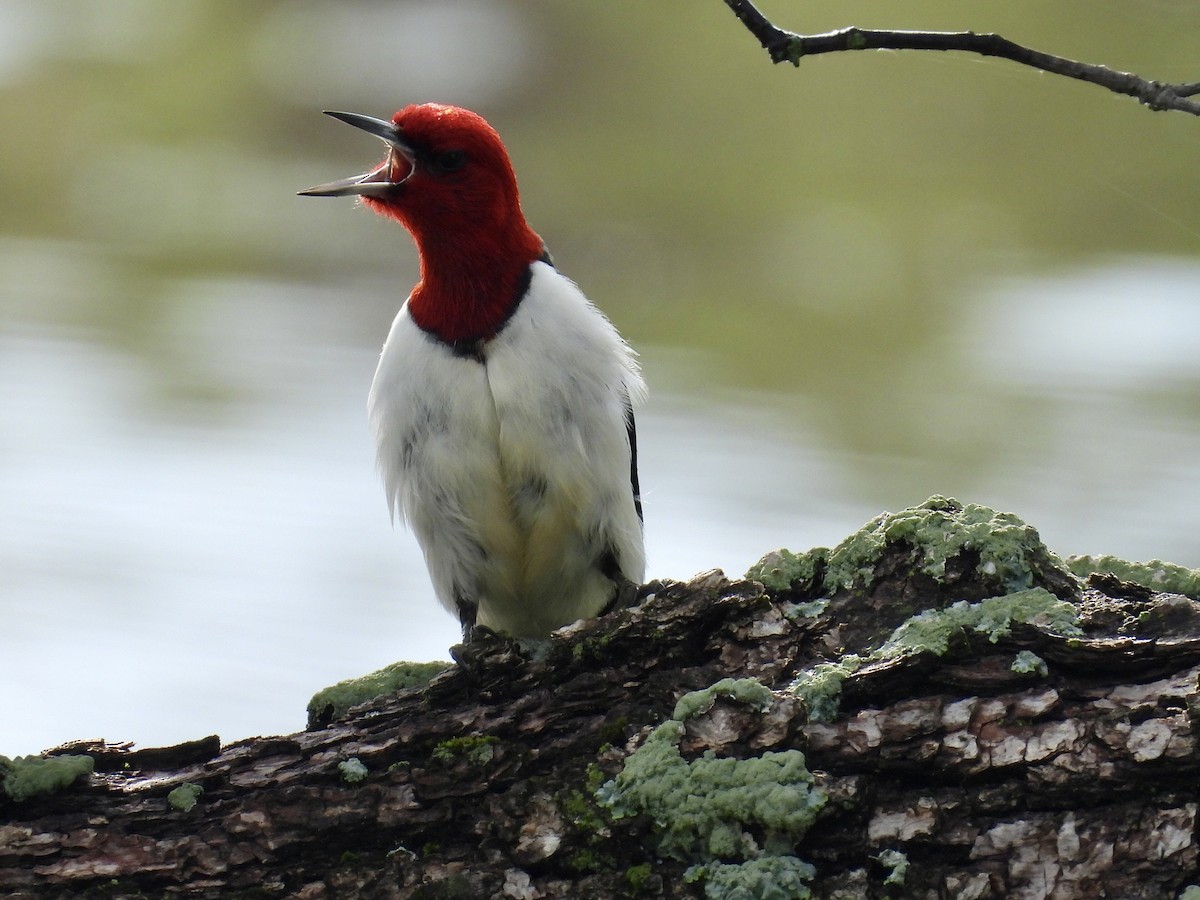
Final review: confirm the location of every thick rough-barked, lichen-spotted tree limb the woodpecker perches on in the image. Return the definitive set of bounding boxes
[0,499,1200,900]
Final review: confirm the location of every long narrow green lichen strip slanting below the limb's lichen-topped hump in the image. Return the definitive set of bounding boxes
[791,588,1082,722]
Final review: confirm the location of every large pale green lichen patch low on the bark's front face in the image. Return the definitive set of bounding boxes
[596,679,827,898]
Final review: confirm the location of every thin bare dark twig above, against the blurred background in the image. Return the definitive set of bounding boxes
[725,0,1200,115]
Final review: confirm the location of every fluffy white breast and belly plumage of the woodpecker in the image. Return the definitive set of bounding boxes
[368,263,646,636]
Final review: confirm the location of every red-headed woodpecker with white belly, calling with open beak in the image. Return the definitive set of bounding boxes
[299,103,646,641]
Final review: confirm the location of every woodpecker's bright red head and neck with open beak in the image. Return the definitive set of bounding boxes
[300,103,545,341]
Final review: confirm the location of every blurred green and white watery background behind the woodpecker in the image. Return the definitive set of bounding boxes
[0,0,1200,755]
